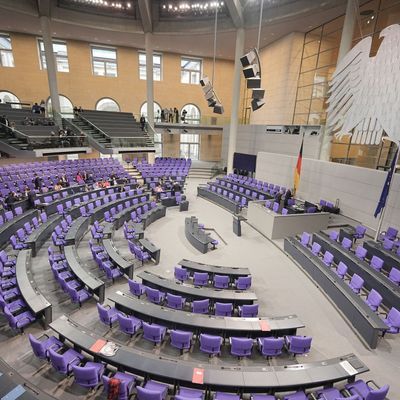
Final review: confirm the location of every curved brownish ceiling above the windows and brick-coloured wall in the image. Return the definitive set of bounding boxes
[0,0,354,60]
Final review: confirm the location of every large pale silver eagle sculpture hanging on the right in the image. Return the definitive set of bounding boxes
[326,24,400,144]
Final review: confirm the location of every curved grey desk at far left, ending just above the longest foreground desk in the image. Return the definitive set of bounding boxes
[15,250,52,329]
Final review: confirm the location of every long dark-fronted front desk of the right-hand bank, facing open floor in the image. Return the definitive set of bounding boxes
[284,238,387,349]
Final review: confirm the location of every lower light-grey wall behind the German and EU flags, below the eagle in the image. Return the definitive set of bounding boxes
[256,151,400,230]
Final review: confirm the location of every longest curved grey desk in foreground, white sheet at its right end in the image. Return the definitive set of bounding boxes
[50,316,368,394]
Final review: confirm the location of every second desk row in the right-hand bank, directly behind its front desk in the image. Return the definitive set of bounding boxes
[313,233,400,309]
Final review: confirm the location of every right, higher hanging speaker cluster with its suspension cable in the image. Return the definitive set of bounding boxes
[240,0,265,111]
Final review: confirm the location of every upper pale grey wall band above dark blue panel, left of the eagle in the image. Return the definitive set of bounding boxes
[221,125,322,163]
